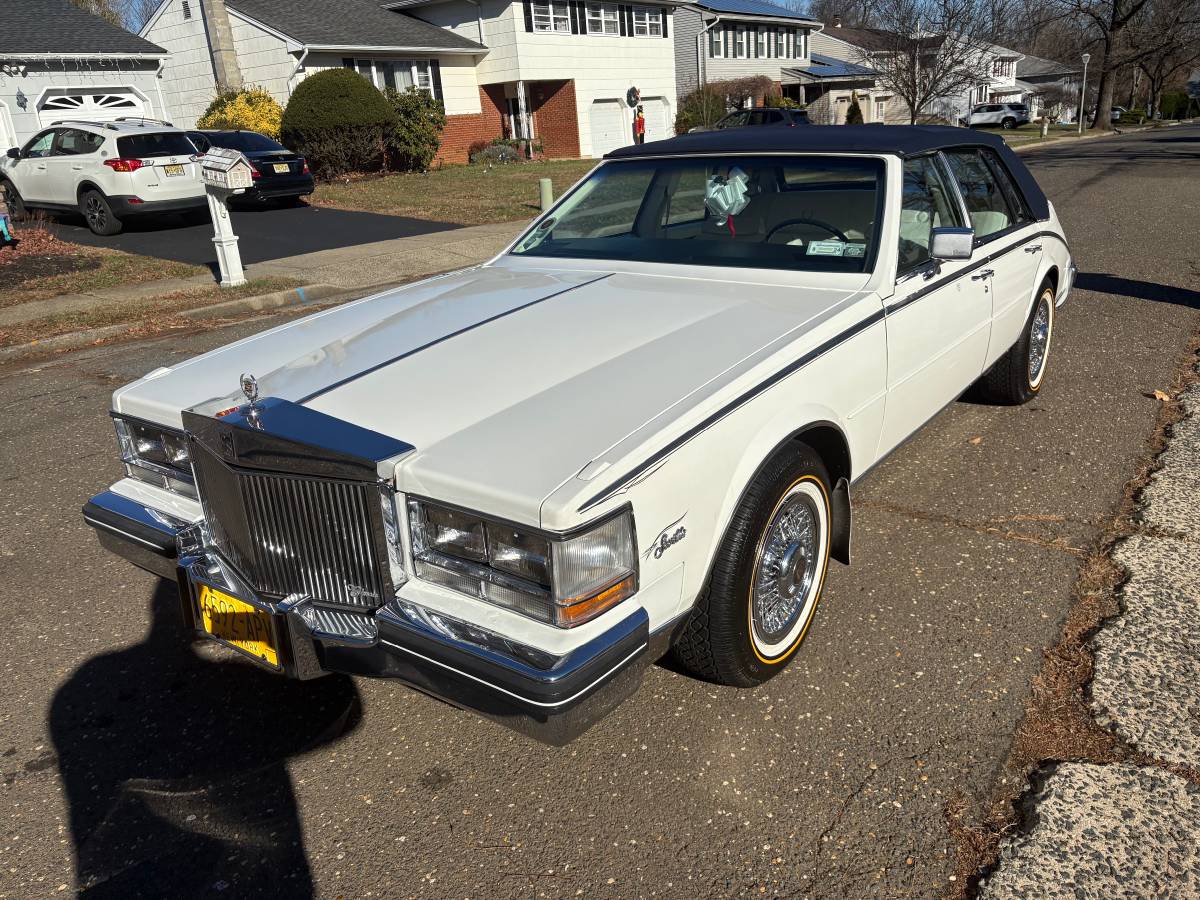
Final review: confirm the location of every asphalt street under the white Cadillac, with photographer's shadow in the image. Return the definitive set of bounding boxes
[7,128,1200,898]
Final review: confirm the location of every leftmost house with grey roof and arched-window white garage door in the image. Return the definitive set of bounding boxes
[0,0,168,152]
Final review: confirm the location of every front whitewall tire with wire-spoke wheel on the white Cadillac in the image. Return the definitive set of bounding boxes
[673,444,830,688]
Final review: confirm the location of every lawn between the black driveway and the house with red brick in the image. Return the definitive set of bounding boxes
[310,160,596,224]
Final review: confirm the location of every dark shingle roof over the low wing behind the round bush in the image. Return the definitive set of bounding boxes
[228,0,485,50]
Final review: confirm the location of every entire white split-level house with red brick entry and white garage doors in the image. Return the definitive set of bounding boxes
[142,0,674,162]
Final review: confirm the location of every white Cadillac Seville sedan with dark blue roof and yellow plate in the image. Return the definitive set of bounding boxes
[84,126,1075,743]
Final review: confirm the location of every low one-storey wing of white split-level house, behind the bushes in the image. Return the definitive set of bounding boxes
[140,0,487,160]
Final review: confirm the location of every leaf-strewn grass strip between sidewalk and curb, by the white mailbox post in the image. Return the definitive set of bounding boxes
[0,277,304,347]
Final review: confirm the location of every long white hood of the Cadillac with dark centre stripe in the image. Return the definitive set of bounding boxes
[115,266,866,524]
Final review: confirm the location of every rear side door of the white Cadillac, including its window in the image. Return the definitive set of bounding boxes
[946,149,1042,366]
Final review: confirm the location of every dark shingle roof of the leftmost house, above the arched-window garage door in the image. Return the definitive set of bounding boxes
[0,0,167,56]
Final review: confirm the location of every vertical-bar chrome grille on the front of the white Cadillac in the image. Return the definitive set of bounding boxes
[192,440,386,610]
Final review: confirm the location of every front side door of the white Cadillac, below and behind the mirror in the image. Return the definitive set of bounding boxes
[878,154,991,456]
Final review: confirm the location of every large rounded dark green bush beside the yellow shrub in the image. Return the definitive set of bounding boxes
[281,68,397,179]
